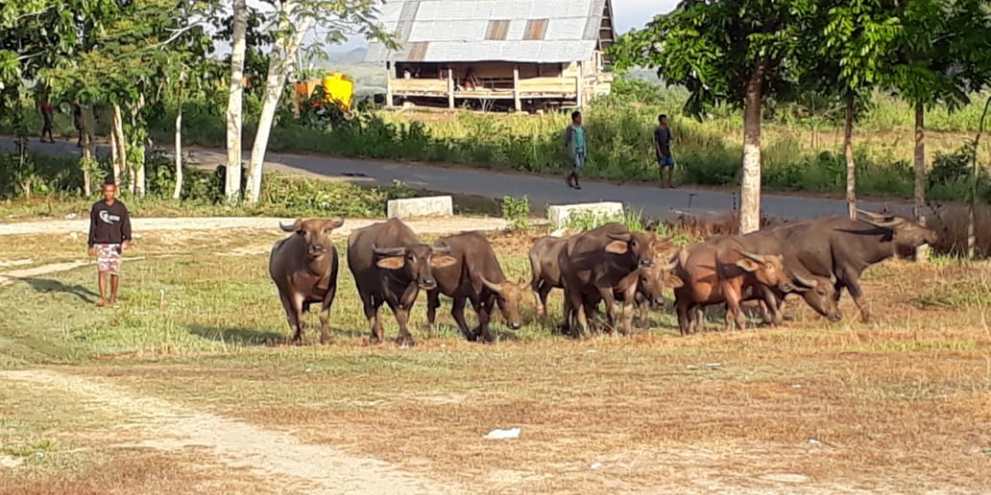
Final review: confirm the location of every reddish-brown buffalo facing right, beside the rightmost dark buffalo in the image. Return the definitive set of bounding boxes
[675,237,789,335]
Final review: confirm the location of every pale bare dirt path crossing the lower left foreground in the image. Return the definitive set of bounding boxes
[0,370,463,495]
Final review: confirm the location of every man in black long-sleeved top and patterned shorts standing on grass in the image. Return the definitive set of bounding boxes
[89,182,131,306]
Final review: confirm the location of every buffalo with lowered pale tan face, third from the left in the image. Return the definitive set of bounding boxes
[427,232,528,342]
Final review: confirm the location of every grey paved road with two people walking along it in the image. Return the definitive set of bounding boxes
[0,137,911,218]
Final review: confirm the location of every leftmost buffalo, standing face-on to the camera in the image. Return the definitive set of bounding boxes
[268,219,344,344]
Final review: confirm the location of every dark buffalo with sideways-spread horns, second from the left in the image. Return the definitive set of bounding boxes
[348,219,456,346]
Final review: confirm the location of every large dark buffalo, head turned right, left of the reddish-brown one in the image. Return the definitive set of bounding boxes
[558,223,669,336]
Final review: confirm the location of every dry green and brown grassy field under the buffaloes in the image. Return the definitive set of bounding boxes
[0,226,991,494]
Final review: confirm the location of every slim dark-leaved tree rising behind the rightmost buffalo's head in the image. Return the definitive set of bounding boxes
[888,0,991,260]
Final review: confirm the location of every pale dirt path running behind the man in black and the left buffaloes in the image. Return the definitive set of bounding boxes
[0,217,506,236]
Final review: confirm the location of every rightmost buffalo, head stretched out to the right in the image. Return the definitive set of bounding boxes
[780,210,938,322]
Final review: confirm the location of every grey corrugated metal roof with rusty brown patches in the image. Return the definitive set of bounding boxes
[365,0,614,63]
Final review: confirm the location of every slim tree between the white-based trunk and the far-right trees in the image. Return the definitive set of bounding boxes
[800,0,902,220]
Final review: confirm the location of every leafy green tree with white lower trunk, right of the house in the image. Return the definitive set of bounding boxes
[612,0,818,233]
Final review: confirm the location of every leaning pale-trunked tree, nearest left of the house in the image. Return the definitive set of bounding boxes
[245,0,394,204]
